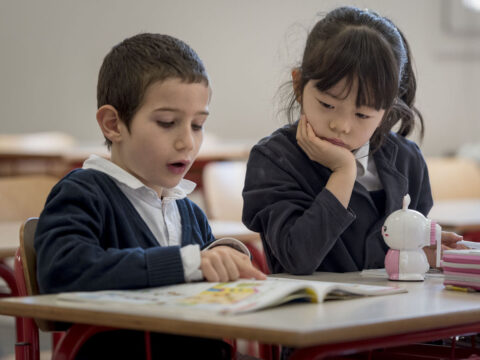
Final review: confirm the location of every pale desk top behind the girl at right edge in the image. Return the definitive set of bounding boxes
[428,198,480,233]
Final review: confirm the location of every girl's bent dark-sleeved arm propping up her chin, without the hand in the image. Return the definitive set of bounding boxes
[243,144,355,274]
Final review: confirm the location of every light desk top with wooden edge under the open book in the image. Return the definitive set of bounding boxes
[0,273,480,347]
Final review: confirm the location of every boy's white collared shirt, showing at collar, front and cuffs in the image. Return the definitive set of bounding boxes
[83,155,250,282]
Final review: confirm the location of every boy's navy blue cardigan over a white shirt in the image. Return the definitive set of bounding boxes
[34,169,214,293]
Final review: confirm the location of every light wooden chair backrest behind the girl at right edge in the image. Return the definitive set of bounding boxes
[426,157,480,200]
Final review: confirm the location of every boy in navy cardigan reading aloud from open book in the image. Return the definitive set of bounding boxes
[35,34,265,359]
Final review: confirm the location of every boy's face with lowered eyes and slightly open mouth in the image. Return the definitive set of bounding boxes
[112,78,210,195]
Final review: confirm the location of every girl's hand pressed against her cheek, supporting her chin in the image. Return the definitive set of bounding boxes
[297,114,355,172]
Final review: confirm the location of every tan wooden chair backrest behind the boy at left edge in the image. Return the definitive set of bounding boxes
[0,175,59,221]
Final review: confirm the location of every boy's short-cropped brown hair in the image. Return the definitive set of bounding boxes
[97,33,209,147]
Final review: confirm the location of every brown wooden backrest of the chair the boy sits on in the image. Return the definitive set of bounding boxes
[16,218,59,331]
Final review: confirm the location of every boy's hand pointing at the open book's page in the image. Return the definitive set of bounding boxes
[200,245,267,282]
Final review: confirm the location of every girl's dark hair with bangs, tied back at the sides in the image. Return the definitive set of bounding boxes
[287,7,424,150]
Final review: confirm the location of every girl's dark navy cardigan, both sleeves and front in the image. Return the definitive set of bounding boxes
[243,124,433,274]
